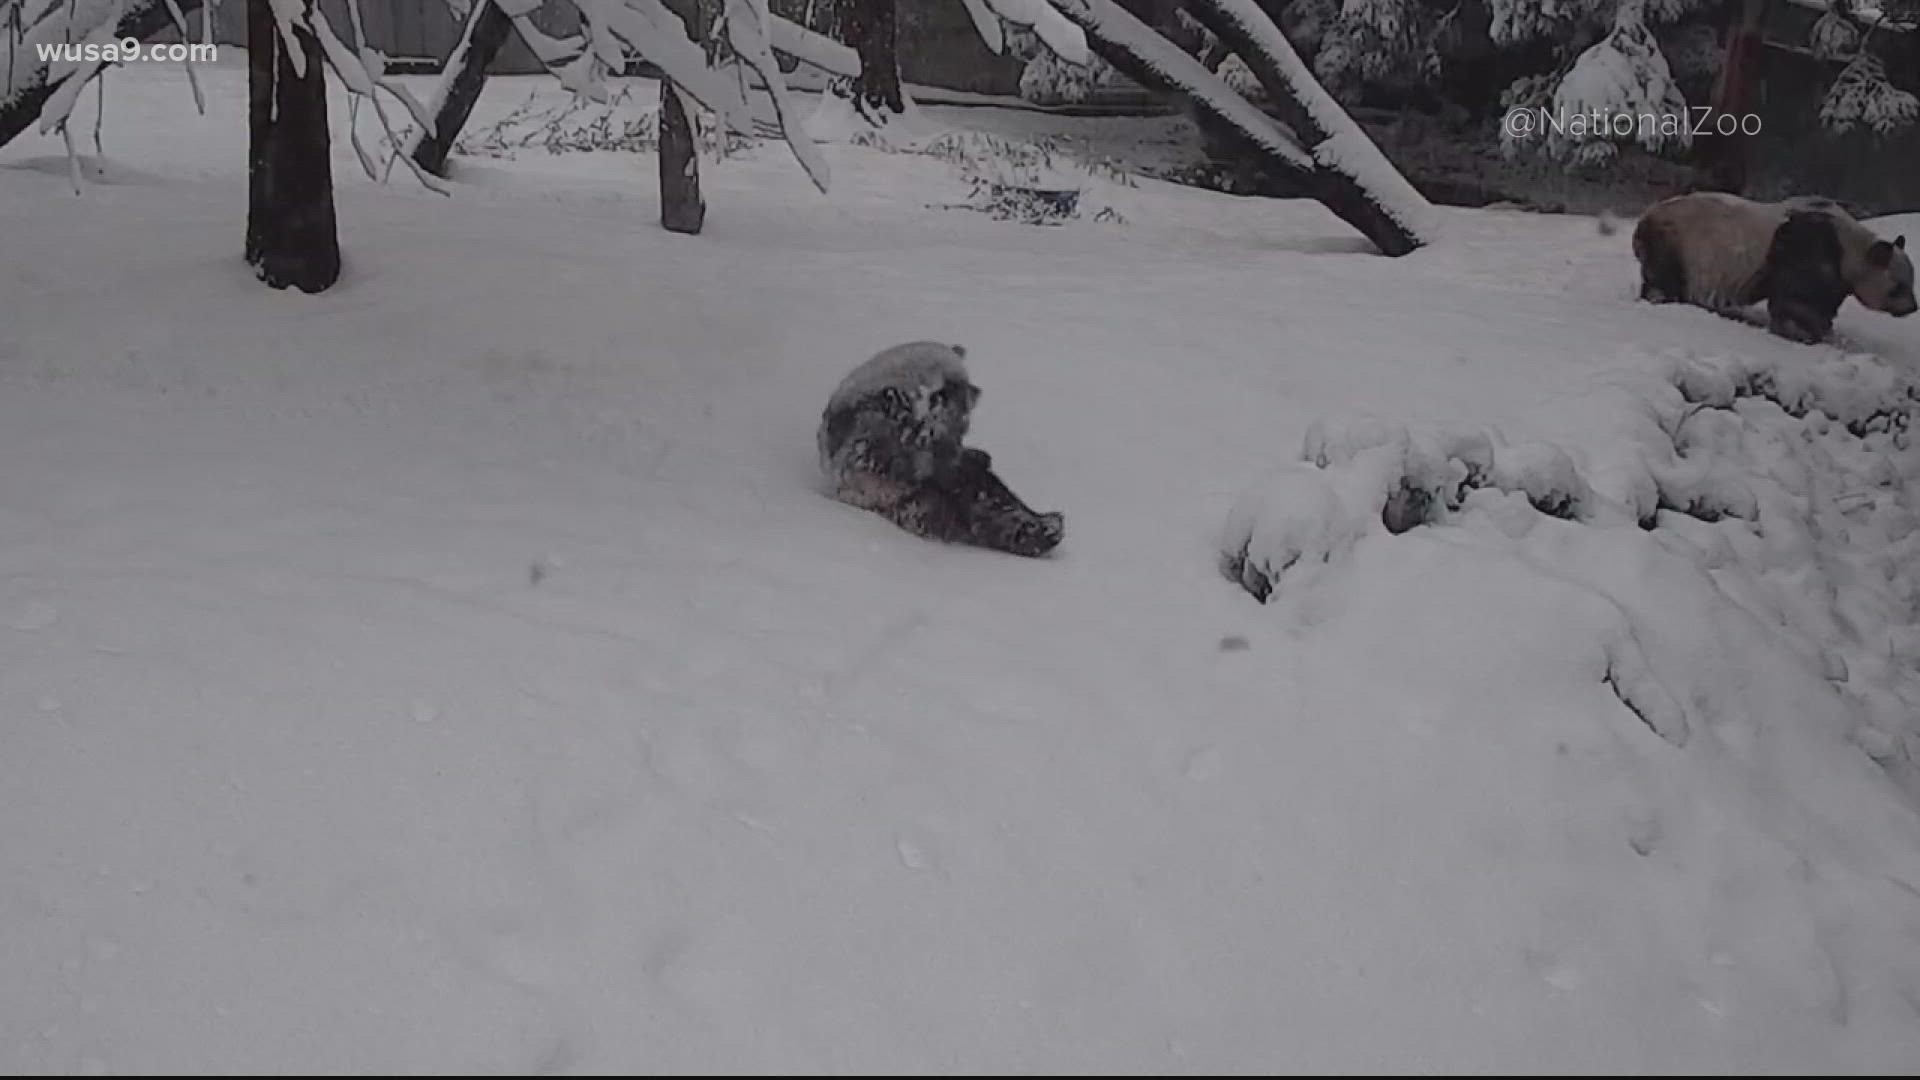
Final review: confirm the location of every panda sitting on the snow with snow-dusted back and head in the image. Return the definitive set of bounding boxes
[818,342,1066,557]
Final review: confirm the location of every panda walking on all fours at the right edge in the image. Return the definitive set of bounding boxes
[1634,192,1914,342]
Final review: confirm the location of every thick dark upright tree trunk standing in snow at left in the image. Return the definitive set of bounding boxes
[246,0,340,292]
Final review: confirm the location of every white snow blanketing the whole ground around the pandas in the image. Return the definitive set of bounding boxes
[0,56,1920,1074]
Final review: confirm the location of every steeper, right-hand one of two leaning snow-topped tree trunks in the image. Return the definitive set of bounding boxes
[1187,0,1425,256]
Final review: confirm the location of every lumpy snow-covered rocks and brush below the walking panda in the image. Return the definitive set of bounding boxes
[1221,342,1920,794]
